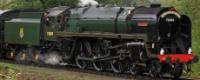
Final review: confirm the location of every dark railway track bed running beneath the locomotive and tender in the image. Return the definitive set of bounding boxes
[1,60,194,80]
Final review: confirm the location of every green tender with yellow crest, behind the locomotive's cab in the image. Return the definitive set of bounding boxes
[4,9,43,46]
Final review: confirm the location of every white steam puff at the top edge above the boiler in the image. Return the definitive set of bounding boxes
[78,0,99,6]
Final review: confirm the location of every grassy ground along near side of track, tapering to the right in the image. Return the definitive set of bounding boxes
[0,63,133,80]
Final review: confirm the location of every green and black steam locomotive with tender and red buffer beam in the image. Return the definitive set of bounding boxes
[0,4,198,77]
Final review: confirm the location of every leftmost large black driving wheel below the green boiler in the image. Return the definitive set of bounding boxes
[76,41,91,69]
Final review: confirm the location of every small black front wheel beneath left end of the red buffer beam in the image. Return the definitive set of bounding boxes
[149,60,162,77]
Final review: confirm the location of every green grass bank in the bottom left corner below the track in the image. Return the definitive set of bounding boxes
[0,63,83,80]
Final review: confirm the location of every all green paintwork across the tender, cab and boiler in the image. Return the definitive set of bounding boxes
[5,7,138,45]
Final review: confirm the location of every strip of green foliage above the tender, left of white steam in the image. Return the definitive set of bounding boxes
[0,0,79,9]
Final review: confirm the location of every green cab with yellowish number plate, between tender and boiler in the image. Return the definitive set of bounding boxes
[43,6,69,41]
